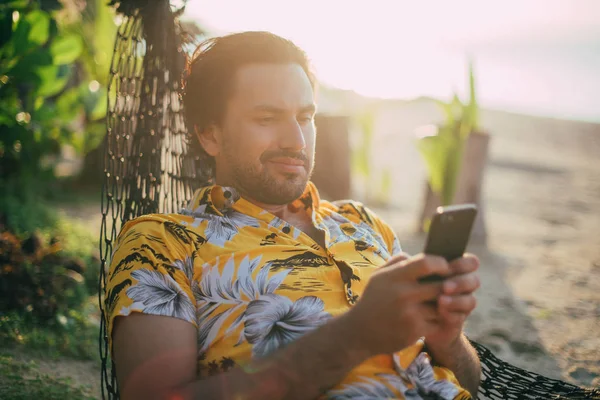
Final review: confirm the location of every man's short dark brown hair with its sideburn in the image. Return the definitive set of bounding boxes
[183,32,316,182]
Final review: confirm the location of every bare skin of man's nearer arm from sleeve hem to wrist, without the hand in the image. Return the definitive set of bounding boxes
[113,314,370,400]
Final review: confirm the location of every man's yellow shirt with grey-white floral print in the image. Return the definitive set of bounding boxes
[105,183,470,399]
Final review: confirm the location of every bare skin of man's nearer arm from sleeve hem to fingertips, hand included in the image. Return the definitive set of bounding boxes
[113,256,460,400]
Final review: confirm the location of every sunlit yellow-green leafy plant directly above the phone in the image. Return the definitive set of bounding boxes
[417,62,479,205]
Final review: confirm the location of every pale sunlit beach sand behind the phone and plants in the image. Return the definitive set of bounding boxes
[360,101,600,386]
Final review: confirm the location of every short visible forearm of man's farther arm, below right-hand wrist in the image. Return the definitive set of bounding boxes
[427,334,481,398]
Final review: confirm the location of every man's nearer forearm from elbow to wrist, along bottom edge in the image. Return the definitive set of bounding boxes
[170,316,369,400]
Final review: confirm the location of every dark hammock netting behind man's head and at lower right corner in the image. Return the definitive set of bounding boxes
[98,0,600,400]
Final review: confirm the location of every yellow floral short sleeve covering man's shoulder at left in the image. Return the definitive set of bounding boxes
[104,214,202,348]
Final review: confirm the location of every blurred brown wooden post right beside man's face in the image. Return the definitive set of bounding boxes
[311,115,352,200]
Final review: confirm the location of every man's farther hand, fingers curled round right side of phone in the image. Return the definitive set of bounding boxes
[425,254,480,352]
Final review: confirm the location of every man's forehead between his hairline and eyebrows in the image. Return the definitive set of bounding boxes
[230,64,314,110]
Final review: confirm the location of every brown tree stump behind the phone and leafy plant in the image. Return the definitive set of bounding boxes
[417,132,490,243]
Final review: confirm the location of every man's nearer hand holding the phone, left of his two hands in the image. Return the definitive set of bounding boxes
[347,255,452,355]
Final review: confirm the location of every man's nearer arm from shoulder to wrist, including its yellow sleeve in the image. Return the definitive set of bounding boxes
[105,215,370,399]
